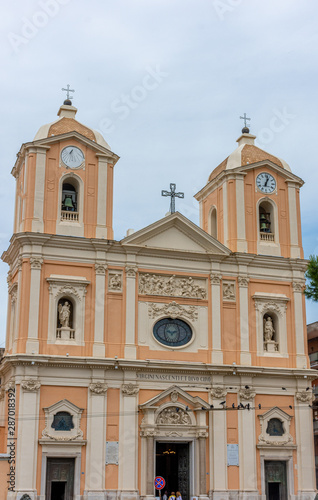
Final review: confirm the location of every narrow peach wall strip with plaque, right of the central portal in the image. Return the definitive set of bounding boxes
[226,393,240,490]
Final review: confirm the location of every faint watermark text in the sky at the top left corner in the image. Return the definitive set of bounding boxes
[8,0,71,54]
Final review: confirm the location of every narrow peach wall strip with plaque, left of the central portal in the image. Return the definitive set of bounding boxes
[105,389,120,490]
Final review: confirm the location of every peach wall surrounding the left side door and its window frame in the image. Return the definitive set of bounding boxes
[36,385,87,494]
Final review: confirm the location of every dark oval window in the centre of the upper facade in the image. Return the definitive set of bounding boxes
[153,318,192,347]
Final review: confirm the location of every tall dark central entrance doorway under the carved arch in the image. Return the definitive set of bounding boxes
[156,442,190,500]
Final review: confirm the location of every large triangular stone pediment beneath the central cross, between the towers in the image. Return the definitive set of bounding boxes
[121,212,231,255]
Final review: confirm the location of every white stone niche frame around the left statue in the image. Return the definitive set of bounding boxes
[46,274,90,345]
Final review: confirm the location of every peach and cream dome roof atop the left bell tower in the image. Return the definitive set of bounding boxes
[34,101,110,150]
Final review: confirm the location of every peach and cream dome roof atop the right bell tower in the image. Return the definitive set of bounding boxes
[209,133,291,181]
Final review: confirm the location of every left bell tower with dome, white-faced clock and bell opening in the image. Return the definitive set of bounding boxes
[12,99,118,239]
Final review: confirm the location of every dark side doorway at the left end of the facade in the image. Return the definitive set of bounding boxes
[46,458,75,500]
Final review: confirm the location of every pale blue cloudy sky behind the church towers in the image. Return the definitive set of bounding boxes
[0,0,318,346]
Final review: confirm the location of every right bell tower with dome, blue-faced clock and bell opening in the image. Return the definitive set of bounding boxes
[195,125,303,258]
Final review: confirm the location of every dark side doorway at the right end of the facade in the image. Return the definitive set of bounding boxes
[265,460,287,500]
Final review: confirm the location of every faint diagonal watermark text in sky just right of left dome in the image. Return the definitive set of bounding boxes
[99,64,169,137]
